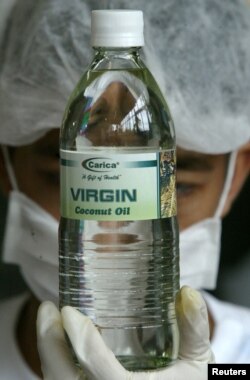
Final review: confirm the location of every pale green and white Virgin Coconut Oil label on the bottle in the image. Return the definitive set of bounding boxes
[60,150,176,221]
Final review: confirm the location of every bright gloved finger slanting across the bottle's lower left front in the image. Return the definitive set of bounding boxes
[62,306,127,380]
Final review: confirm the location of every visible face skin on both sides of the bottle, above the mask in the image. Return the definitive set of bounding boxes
[0,130,228,230]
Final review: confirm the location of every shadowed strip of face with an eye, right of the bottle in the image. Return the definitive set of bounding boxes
[177,148,228,230]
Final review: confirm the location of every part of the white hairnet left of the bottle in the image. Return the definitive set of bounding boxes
[0,0,94,146]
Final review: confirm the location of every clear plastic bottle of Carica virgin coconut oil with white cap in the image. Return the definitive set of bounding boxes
[59,10,179,371]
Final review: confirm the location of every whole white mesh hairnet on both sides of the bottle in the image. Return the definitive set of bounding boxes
[0,0,250,153]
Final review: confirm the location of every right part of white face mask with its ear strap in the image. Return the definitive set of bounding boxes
[180,152,237,289]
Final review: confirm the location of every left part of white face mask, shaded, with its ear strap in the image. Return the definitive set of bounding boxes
[2,147,59,304]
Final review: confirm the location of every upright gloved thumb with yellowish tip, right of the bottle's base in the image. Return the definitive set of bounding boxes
[176,286,214,363]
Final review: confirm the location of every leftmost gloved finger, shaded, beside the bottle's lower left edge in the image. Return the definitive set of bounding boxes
[37,301,81,380]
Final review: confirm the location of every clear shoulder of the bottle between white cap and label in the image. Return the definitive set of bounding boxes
[61,52,175,149]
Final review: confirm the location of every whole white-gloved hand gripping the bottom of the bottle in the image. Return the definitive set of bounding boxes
[37,287,214,380]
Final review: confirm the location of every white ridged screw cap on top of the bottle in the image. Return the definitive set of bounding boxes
[91,9,144,47]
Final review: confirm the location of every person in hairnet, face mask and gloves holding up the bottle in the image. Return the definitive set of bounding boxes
[0,0,250,380]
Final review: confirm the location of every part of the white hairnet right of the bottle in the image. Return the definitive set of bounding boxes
[126,0,250,153]
